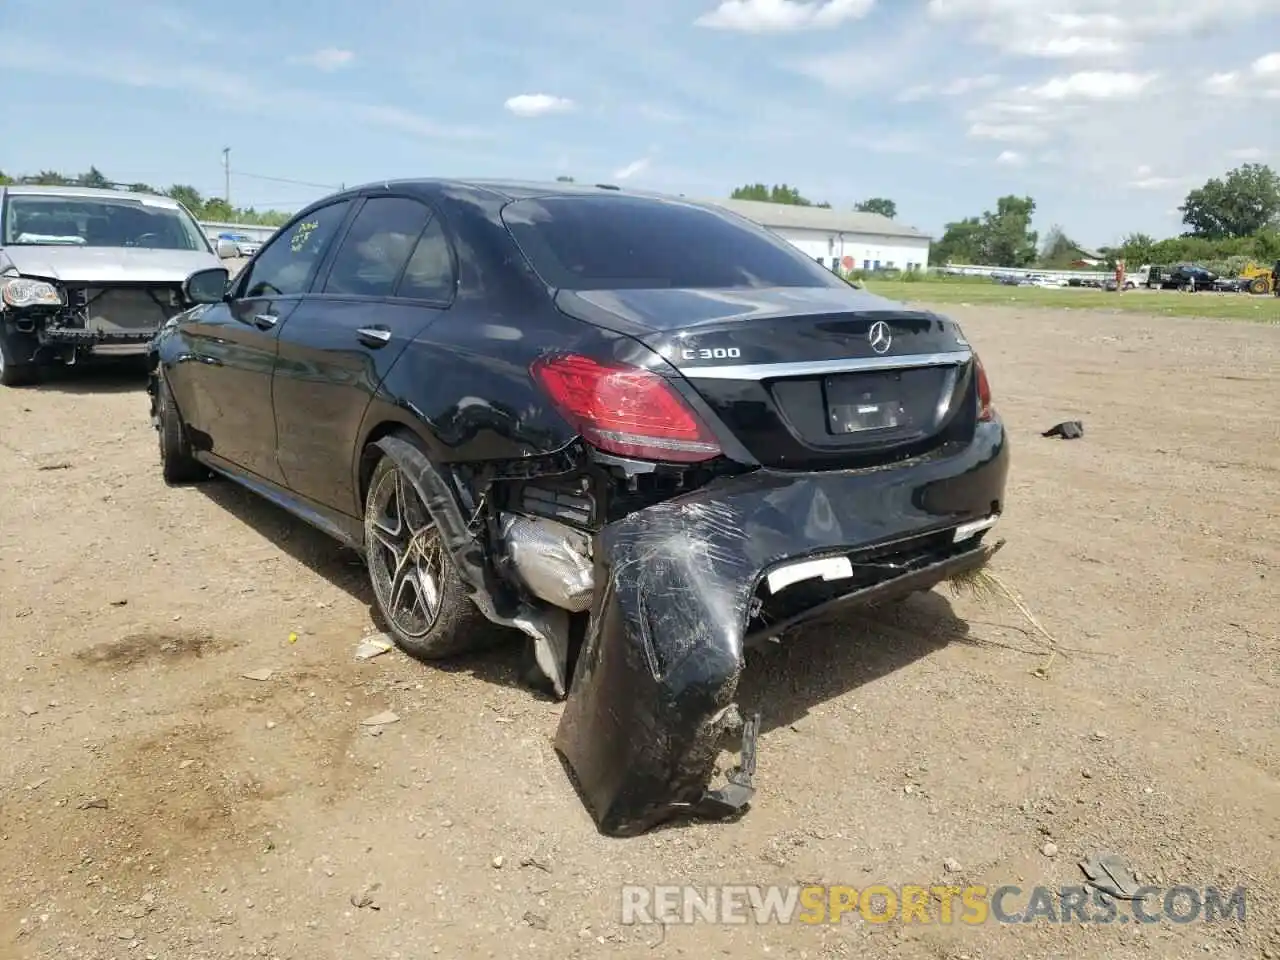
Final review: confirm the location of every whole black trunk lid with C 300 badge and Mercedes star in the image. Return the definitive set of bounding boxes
[558,287,977,470]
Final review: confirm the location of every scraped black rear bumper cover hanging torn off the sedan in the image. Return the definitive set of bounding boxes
[556,421,1009,836]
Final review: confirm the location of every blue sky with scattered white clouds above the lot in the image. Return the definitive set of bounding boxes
[0,0,1280,244]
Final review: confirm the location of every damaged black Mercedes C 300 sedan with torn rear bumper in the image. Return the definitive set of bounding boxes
[150,179,1009,836]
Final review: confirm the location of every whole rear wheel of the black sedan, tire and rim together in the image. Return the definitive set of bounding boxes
[365,435,499,660]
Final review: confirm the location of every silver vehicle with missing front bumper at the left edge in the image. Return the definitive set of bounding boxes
[0,186,230,387]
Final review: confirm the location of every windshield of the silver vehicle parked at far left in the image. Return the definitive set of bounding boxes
[4,193,210,252]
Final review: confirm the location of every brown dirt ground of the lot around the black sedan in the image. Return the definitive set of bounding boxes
[0,307,1280,960]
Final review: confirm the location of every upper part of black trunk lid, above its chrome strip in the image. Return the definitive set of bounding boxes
[556,284,968,376]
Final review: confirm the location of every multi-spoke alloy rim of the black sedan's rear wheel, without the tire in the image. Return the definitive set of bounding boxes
[365,468,444,639]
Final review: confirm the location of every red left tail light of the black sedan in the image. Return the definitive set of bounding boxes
[530,353,721,463]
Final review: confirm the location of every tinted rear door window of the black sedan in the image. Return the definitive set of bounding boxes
[324,197,431,297]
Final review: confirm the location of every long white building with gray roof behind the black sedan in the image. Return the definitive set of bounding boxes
[699,200,933,270]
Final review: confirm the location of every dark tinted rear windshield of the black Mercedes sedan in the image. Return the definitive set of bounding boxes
[502,196,844,291]
